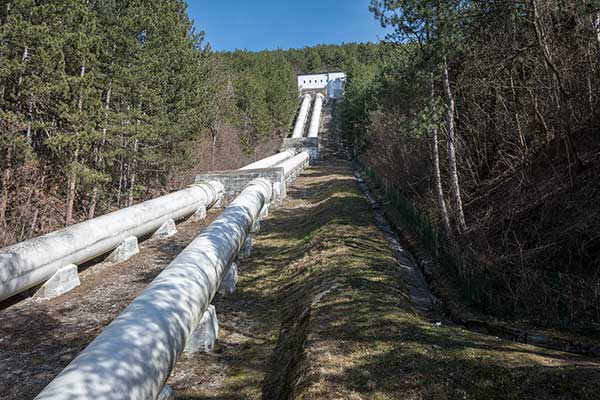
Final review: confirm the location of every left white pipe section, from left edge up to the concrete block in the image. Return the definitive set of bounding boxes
[0,181,223,301]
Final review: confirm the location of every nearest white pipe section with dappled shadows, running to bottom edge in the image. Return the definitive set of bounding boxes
[36,179,272,400]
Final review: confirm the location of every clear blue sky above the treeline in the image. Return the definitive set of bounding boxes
[187,0,385,51]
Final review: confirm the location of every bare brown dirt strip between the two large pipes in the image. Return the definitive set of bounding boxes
[0,212,217,400]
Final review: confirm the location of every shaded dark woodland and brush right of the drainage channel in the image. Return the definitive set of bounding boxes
[341,0,600,334]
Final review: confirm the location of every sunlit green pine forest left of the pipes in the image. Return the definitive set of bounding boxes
[0,0,297,246]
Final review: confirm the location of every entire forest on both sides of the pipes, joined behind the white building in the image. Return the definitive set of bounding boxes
[0,0,600,333]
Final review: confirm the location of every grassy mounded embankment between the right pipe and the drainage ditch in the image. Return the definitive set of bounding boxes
[170,156,600,400]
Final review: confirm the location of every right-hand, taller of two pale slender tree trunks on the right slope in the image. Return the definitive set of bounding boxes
[444,59,467,232]
